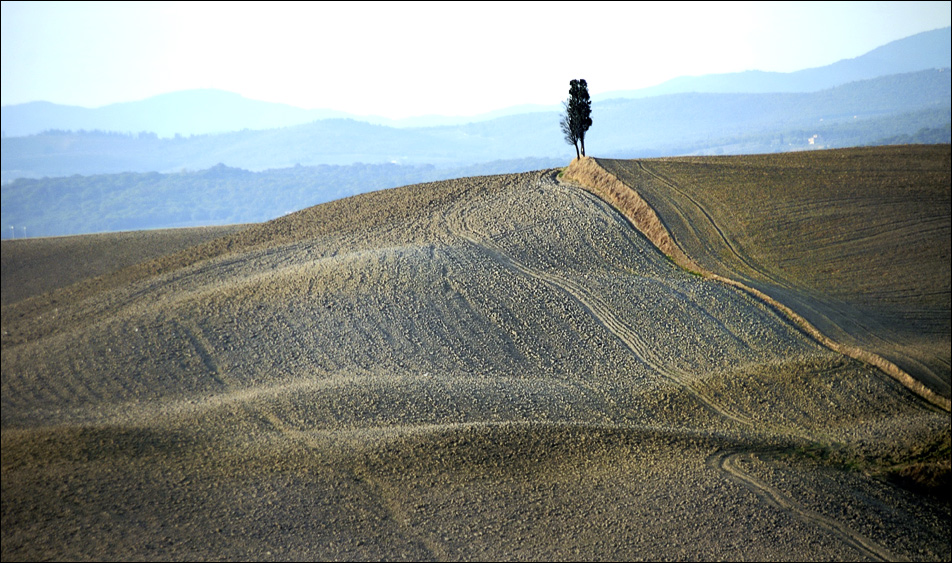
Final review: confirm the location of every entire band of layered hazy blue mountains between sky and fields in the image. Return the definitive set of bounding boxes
[0,28,952,237]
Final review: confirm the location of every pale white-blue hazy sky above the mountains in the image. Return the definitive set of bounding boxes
[0,1,952,118]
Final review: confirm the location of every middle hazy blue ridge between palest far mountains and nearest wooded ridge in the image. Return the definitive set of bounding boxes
[0,69,952,182]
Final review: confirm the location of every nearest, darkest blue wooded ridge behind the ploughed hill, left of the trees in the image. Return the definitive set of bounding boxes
[0,158,567,239]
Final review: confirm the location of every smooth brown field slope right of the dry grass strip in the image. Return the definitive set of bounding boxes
[572,145,952,399]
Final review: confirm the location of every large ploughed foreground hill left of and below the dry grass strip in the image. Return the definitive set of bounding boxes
[0,159,952,561]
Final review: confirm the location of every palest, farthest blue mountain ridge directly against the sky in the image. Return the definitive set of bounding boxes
[0,28,952,137]
